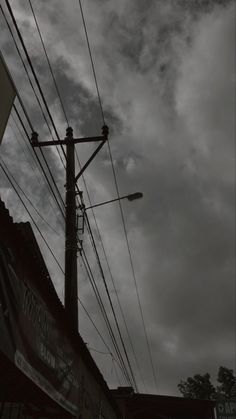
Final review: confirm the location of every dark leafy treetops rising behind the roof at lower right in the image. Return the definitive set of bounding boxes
[178,367,236,400]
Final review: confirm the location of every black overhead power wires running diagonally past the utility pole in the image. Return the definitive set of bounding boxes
[0,0,157,392]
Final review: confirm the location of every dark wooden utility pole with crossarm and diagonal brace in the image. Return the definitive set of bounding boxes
[31,125,109,332]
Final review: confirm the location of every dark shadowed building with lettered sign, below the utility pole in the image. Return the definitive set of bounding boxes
[0,200,120,419]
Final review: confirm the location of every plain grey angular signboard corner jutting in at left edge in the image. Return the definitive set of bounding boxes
[0,53,16,144]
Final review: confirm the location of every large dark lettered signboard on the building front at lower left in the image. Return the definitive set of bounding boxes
[0,245,81,416]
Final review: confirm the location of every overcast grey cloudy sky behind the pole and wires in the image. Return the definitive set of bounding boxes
[0,0,235,395]
